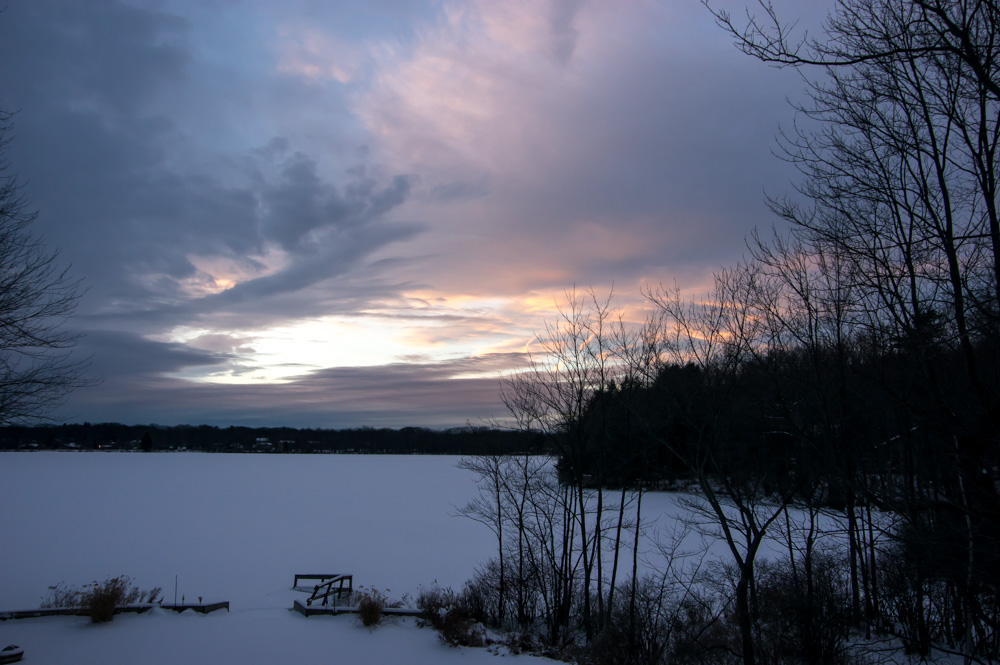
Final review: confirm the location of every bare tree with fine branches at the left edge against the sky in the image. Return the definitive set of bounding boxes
[0,111,88,425]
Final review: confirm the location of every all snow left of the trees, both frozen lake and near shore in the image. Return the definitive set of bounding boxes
[0,452,560,665]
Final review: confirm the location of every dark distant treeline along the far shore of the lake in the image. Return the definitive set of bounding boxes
[0,423,543,455]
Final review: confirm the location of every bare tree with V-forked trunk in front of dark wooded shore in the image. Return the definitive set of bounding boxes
[647,262,795,665]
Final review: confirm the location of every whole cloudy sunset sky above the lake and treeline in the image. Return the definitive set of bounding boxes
[0,0,825,428]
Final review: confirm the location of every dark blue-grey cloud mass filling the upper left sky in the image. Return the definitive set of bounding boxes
[0,0,419,325]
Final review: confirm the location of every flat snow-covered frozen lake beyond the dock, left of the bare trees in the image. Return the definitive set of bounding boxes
[0,452,494,609]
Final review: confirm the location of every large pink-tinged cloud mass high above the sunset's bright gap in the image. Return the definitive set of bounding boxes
[357,0,784,306]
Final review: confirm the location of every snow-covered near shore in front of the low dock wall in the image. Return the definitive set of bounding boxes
[0,607,524,665]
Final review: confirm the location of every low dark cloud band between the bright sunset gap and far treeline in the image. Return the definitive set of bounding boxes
[56,339,524,427]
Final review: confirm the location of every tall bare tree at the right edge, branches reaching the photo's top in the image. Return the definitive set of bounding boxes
[715,0,1000,660]
